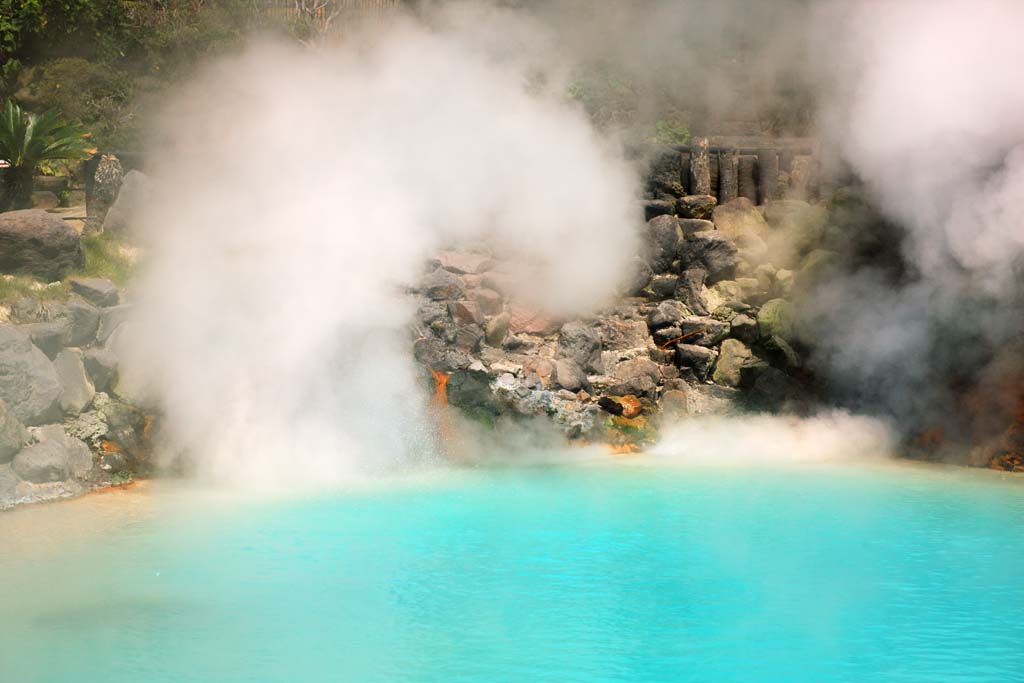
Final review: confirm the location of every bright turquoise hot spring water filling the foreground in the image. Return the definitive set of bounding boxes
[0,465,1024,683]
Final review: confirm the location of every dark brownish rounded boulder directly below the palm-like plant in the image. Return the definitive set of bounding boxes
[0,209,85,282]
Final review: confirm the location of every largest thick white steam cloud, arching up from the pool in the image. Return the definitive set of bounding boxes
[130,5,639,482]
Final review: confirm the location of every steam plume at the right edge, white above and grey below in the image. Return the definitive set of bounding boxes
[810,0,1024,440]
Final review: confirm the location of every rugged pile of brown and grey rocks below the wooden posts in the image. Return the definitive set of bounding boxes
[405,196,823,446]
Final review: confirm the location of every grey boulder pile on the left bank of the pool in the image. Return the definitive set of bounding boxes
[0,278,150,509]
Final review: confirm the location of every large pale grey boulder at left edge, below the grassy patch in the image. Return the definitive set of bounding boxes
[0,325,60,425]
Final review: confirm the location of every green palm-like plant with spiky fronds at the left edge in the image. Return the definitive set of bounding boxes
[0,100,90,211]
